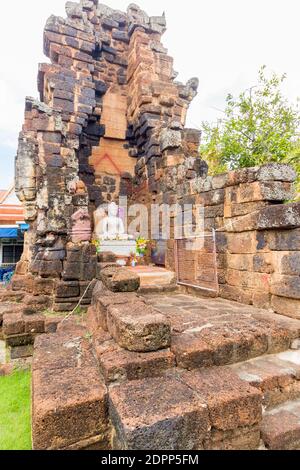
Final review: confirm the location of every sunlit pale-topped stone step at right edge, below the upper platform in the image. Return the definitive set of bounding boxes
[231,350,300,409]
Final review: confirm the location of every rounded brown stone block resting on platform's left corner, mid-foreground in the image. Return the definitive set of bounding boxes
[107,302,171,352]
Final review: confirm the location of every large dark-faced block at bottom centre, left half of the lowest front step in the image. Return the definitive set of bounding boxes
[109,377,209,451]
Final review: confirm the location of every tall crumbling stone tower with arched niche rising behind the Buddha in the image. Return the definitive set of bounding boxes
[16,2,202,311]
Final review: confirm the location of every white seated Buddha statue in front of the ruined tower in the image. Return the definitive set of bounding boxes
[96,202,132,240]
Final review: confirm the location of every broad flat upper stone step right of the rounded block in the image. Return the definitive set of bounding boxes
[148,294,300,370]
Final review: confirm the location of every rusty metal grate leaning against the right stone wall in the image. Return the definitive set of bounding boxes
[175,231,219,293]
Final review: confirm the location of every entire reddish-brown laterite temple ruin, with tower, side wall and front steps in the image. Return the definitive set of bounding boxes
[0,0,300,450]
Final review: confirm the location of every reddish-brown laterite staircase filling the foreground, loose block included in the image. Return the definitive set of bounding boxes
[28,283,300,450]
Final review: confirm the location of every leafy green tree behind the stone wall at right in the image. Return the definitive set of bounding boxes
[201,66,300,184]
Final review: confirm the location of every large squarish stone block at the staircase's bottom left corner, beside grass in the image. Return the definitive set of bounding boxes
[32,367,109,450]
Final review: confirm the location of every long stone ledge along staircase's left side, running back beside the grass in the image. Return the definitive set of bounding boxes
[32,328,110,450]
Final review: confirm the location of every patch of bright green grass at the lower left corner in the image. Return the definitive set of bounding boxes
[0,371,31,450]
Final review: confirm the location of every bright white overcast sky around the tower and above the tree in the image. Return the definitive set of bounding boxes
[0,0,300,188]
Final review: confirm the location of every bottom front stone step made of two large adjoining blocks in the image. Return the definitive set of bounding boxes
[109,367,262,450]
